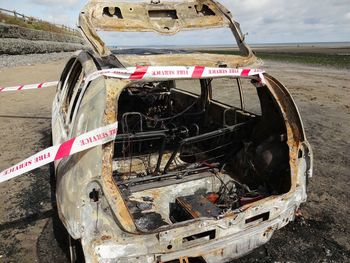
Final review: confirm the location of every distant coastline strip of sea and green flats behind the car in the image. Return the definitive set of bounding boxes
[112,42,350,69]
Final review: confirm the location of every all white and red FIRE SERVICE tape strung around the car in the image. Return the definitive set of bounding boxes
[0,66,265,183]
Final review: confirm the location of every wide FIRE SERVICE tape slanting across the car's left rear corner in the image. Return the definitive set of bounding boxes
[0,122,118,183]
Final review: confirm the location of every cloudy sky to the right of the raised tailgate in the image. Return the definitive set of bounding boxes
[222,0,350,43]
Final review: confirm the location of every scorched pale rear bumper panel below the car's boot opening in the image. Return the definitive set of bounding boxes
[93,203,299,263]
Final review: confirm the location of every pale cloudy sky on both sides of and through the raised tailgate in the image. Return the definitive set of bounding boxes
[0,0,350,45]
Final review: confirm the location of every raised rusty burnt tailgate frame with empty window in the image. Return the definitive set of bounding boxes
[78,0,256,66]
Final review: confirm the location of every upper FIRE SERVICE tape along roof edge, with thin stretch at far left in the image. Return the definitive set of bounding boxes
[0,66,265,93]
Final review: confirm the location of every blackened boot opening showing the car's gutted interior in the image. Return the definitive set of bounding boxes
[113,78,291,232]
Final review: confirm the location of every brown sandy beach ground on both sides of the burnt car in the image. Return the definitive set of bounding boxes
[0,58,350,262]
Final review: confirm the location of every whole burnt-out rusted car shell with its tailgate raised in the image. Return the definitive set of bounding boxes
[52,0,312,263]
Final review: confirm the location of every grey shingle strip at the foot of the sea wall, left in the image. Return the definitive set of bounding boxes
[0,52,74,69]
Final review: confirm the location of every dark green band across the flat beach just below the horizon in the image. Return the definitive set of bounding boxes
[200,50,350,69]
